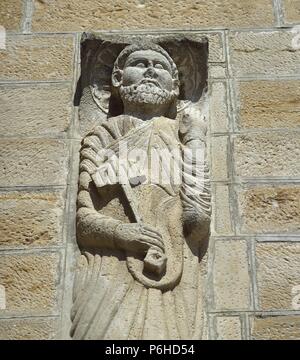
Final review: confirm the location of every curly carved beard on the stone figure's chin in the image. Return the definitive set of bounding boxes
[119,83,176,105]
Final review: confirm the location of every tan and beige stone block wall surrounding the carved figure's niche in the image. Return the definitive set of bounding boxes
[0,0,300,339]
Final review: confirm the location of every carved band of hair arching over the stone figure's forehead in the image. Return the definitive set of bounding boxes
[113,42,179,84]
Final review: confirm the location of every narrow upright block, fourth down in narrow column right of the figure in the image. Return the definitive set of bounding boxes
[211,136,228,181]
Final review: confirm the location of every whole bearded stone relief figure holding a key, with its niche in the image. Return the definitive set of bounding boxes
[71,34,211,339]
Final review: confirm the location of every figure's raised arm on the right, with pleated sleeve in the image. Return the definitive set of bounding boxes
[179,109,211,240]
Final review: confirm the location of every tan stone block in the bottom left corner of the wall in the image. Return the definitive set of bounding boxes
[0,318,58,340]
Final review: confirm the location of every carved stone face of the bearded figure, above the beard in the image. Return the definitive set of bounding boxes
[122,50,173,91]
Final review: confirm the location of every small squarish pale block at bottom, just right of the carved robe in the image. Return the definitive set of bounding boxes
[216,316,242,340]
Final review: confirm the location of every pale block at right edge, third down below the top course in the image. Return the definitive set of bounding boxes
[234,132,300,178]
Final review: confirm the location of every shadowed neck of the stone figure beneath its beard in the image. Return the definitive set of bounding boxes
[124,102,170,120]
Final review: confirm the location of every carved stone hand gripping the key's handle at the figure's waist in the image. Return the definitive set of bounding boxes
[114,223,164,254]
